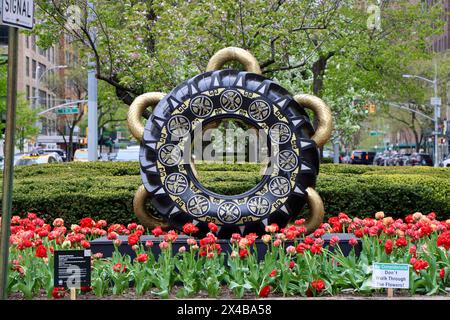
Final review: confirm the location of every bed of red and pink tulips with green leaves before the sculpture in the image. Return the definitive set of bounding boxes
[3,212,450,299]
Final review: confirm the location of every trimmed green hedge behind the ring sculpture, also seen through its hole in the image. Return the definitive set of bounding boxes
[1,162,450,224]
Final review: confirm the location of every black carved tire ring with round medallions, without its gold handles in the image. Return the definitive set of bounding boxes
[140,70,319,238]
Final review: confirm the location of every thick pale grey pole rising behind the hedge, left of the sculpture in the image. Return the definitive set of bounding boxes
[87,2,98,161]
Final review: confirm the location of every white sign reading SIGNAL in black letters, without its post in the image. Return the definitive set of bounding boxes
[1,0,34,30]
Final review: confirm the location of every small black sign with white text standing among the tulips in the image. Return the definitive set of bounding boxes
[54,250,91,288]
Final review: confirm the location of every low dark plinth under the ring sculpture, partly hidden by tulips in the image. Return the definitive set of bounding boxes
[90,233,362,260]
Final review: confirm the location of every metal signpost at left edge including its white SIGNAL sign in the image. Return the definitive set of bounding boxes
[0,0,34,299]
